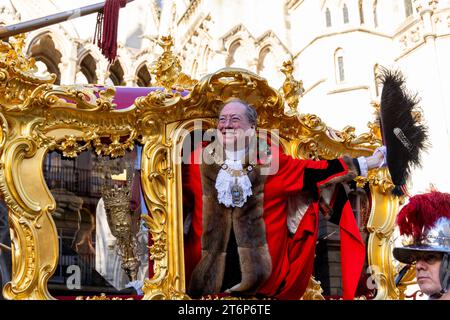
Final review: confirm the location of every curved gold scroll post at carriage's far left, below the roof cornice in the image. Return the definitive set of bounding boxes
[0,138,58,299]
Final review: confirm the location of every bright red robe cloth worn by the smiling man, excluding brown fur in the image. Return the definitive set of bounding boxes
[183,147,365,300]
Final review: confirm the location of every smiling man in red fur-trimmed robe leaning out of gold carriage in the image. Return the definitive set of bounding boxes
[183,99,384,299]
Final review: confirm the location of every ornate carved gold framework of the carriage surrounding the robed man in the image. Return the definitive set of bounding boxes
[0,37,400,299]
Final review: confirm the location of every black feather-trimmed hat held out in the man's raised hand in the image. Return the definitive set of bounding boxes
[380,68,428,196]
